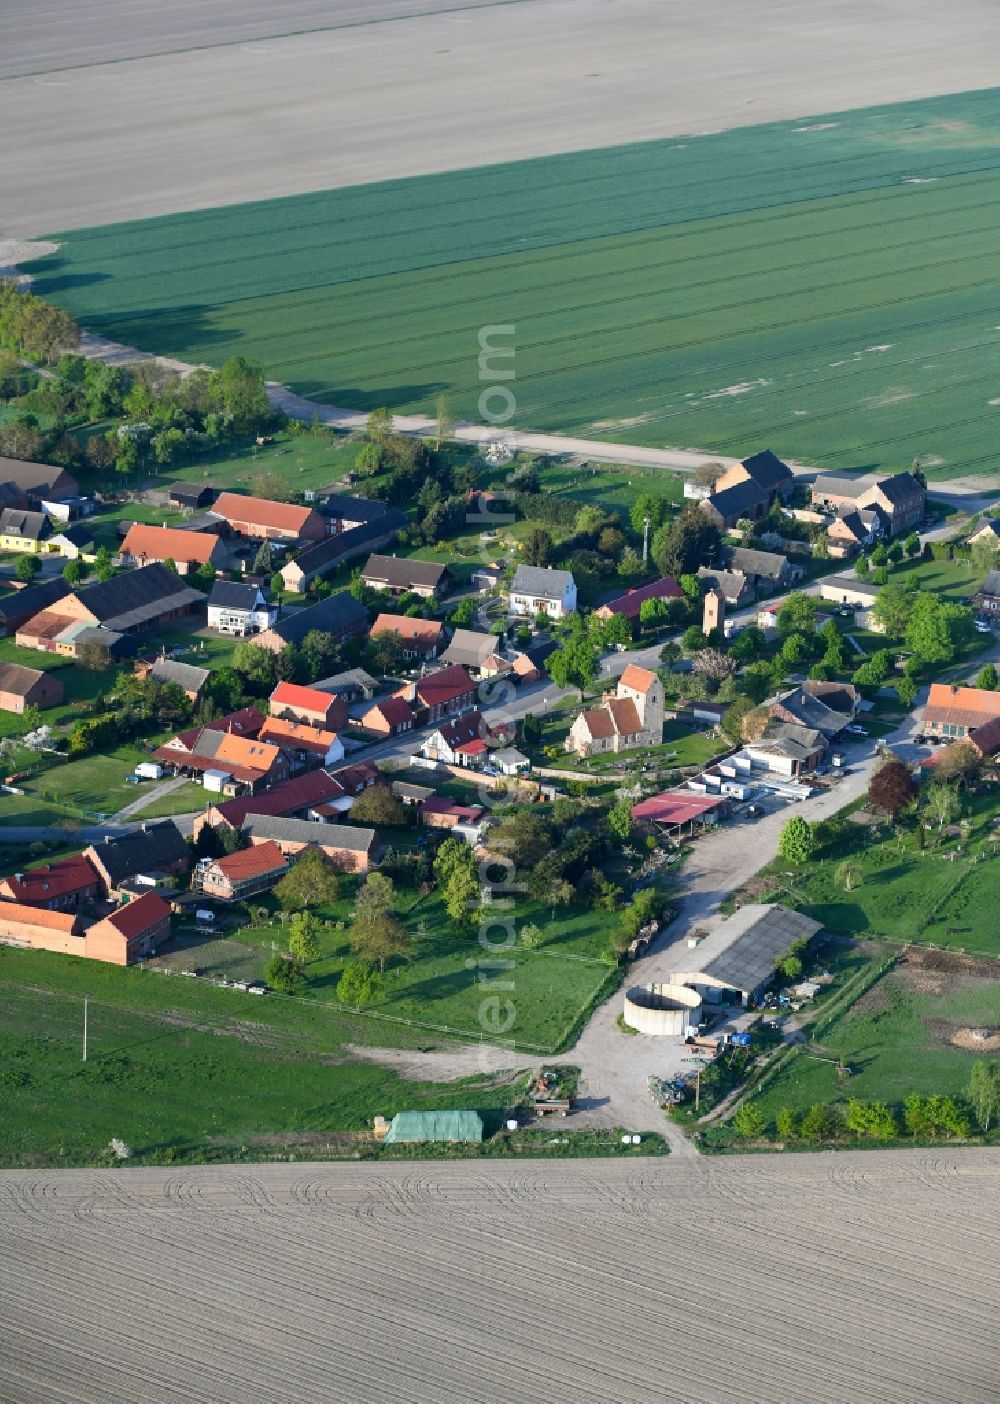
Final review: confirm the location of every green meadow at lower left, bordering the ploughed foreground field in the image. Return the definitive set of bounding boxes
[0,949,530,1167]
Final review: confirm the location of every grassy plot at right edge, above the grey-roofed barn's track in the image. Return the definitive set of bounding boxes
[753,788,1000,958]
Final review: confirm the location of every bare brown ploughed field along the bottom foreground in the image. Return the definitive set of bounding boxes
[0,1150,1000,1404]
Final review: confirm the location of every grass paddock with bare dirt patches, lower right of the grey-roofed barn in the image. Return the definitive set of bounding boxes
[754,965,1000,1119]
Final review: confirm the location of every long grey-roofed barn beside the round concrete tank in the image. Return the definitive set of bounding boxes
[671,903,822,994]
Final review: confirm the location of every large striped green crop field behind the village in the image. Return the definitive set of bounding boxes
[31,91,1000,477]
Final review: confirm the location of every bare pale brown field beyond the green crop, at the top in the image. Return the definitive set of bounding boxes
[0,0,1000,237]
